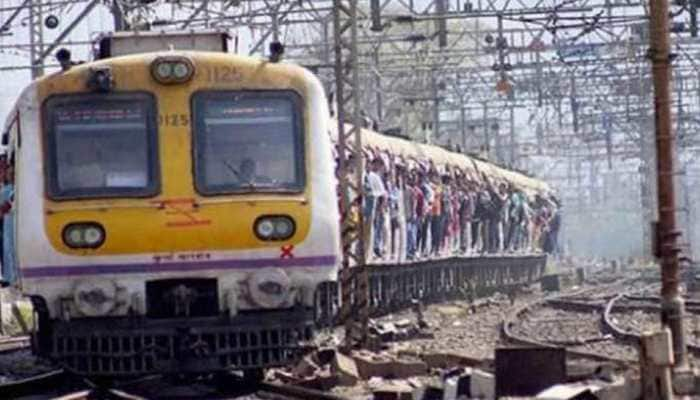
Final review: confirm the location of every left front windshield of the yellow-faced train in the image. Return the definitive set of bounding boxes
[44,93,159,199]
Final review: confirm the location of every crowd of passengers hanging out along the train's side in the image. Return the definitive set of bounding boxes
[336,152,561,262]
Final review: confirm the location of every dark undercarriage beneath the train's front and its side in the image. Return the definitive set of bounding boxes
[28,255,546,377]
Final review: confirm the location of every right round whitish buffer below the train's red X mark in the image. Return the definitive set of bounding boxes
[248,268,291,308]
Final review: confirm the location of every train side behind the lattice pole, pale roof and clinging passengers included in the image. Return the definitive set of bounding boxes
[331,121,561,264]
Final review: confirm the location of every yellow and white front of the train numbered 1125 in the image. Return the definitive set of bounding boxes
[4,32,340,376]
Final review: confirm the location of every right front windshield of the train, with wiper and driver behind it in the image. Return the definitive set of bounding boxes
[193,91,304,194]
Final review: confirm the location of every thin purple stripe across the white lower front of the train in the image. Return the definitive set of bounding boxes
[22,256,337,278]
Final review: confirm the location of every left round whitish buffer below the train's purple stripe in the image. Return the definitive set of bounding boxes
[73,279,118,317]
